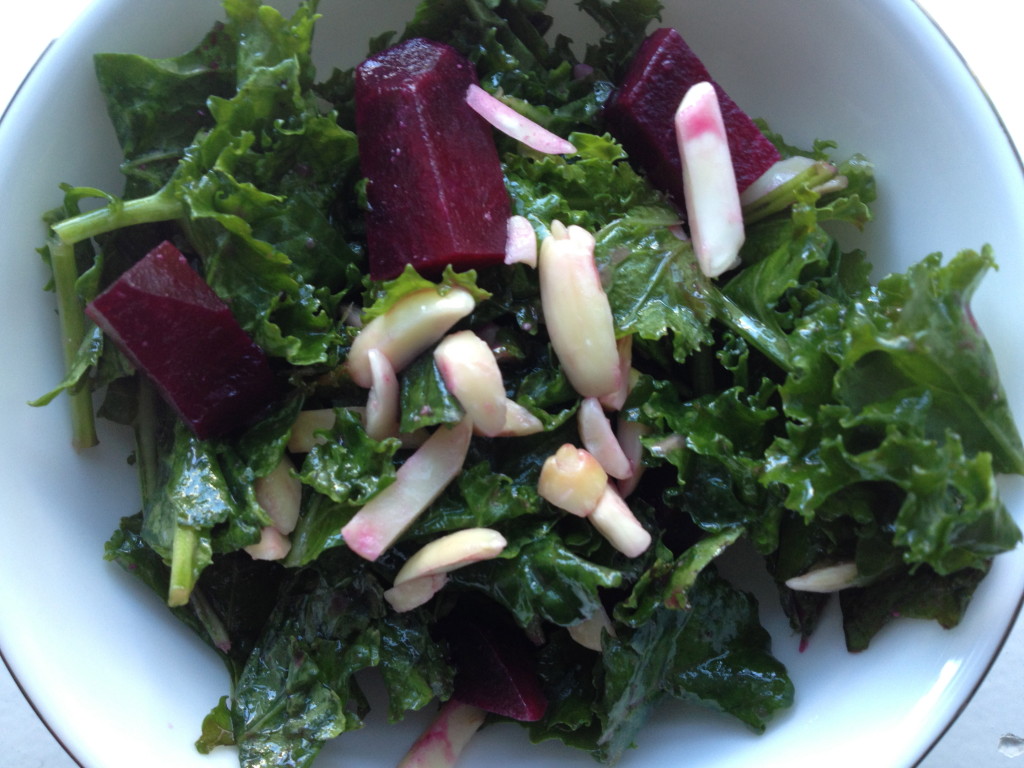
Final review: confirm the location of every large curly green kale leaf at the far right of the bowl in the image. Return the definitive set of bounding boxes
[765,247,1022,573]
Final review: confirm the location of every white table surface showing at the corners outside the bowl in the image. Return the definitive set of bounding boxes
[0,0,1024,768]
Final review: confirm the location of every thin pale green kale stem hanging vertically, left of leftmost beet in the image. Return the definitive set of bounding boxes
[49,239,97,451]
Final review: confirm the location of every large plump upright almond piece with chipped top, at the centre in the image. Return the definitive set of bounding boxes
[538,221,622,397]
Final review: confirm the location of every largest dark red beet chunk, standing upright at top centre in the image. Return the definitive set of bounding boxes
[355,38,511,280]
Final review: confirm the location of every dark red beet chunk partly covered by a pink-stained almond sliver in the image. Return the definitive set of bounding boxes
[605,29,780,210]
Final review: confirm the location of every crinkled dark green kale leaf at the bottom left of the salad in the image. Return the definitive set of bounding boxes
[231,550,452,767]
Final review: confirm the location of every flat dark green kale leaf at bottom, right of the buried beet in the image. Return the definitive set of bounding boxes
[530,565,794,763]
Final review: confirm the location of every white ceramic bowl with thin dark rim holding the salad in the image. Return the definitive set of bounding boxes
[0,0,1024,768]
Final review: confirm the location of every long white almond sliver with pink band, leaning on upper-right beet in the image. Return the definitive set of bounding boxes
[675,82,745,278]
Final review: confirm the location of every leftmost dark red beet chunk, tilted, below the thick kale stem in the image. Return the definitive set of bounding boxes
[85,242,278,439]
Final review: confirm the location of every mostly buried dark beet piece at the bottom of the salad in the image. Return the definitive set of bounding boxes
[444,620,548,722]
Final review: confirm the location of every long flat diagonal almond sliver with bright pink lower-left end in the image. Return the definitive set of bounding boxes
[341,419,473,560]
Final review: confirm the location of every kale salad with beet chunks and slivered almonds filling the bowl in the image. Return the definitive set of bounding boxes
[12,0,1024,766]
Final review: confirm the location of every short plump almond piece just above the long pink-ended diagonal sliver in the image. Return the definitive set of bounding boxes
[434,331,508,437]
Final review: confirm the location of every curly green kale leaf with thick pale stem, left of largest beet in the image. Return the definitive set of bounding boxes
[51,0,362,366]
